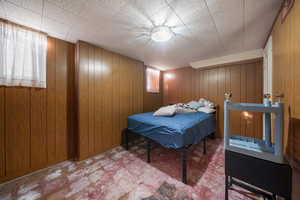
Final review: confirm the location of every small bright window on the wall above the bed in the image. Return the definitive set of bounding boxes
[146,67,160,93]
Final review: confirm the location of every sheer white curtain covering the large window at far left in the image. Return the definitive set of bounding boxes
[0,21,47,88]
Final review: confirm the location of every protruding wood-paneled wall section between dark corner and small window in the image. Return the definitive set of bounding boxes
[76,42,144,160]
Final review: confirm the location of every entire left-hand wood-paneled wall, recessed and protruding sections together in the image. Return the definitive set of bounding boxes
[0,37,162,182]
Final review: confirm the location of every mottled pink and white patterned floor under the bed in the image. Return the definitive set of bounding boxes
[0,139,257,200]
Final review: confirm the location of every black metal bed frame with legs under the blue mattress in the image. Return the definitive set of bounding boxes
[124,106,218,184]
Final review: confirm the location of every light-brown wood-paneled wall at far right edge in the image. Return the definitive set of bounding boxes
[272,1,300,169]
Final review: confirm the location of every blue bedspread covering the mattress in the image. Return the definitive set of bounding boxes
[128,112,216,149]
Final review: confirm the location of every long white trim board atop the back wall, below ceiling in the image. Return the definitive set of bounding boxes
[190,49,263,68]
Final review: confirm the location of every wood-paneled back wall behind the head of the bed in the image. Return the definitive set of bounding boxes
[164,60,263,138]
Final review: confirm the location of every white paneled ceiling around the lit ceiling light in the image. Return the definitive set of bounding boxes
[0,0,281,69]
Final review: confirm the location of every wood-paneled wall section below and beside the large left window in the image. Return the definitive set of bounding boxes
[0,37,75,182]
